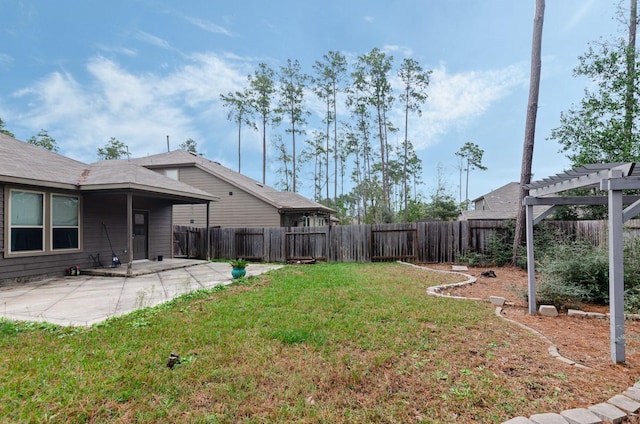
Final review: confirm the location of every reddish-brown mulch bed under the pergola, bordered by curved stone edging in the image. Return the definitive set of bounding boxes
[424,264,640,372]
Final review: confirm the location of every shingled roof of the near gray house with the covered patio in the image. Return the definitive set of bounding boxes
[0,133,218,201]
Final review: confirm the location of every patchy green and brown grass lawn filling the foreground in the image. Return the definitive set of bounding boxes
[0,264,628,423]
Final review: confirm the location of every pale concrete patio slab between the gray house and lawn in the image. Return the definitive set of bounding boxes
[0,260,281,326]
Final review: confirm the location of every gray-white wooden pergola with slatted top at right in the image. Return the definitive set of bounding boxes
[524,163,640,363]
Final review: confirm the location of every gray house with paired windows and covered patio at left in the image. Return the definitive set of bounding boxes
[0,133,217,282]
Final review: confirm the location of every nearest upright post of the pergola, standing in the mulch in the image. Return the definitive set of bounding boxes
[603,171,625,363]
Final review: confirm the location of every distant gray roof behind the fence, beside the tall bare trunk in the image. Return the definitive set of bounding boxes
[460,182,549,220]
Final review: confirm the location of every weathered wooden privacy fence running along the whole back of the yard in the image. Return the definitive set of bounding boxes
[174,220,640,263]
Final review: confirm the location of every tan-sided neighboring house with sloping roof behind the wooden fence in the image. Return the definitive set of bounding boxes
[131,150,335,227]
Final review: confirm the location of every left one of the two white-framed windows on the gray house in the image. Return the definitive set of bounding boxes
[9,190,44,252]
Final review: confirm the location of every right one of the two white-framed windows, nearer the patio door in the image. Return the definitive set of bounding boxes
[51,194,80,250]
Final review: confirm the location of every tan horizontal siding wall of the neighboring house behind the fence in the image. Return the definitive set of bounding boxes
[173,167,280,227]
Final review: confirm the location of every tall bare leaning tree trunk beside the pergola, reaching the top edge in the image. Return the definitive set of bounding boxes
[511,0,545,265]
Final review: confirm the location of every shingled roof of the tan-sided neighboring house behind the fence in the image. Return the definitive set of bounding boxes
[131,150,336,213]
